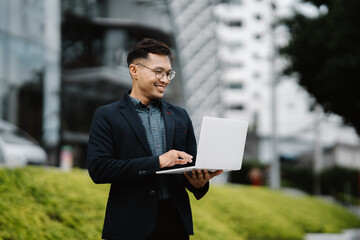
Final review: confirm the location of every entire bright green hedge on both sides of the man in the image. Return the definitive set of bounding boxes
[0,167,360,240]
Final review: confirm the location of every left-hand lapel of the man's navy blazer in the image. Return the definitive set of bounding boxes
[120,95,152,156]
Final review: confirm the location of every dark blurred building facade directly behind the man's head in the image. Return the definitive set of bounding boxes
[61,0,184,167]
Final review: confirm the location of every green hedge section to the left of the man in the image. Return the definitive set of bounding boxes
[0,167,108,240]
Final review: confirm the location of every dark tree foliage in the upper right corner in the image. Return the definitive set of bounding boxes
[280,0,360,135]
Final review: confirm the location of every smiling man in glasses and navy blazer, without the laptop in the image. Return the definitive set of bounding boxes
[87,39,222,240]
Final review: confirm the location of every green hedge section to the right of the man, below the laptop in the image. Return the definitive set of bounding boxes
[192,185,360,240]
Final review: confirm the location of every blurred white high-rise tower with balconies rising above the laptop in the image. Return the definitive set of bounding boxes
[215,0,274,164]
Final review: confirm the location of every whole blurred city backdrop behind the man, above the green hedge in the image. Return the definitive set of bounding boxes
[0,0,360,204]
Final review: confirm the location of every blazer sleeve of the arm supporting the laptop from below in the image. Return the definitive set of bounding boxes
[183,110,210,200]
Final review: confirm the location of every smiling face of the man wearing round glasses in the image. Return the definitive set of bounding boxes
[133,53,171,104]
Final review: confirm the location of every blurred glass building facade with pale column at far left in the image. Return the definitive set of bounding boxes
[0,0,60,164]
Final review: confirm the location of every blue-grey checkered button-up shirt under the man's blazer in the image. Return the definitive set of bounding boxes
[130,96,171,199]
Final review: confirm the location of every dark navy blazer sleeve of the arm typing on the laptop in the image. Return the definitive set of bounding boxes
[87,107,160,183]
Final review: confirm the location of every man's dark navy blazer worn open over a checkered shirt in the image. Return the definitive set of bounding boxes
[87,94,209,240]
